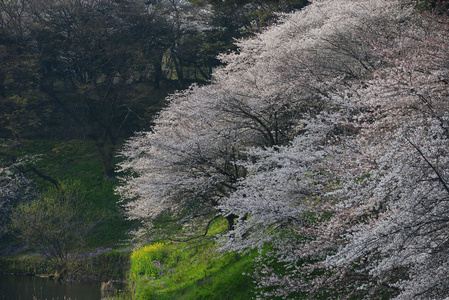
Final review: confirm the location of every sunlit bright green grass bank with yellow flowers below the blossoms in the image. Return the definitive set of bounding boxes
[130,243,254,300]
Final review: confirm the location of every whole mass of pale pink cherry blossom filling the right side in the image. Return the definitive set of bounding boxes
[118,0,449,299]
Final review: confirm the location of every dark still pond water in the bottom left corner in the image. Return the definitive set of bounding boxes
[0,275,105,300]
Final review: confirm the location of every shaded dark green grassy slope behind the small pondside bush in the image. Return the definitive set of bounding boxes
[1,140,133,247]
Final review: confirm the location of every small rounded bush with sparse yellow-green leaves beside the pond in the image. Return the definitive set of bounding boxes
[12,182,100,275]
